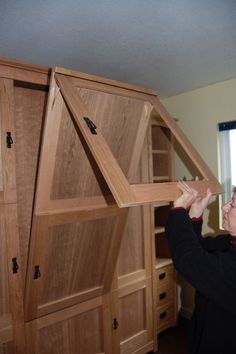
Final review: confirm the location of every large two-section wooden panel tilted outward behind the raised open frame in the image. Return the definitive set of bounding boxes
[26,72,151,319]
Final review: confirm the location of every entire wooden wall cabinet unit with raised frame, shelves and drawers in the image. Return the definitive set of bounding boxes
[0,59,221,354]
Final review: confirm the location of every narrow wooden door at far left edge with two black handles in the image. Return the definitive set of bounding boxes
[0,79,25,353]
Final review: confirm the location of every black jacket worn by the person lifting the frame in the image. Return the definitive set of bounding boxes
[166,208,236,354]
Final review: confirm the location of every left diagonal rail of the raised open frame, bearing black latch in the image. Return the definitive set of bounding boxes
[55,74,135,207]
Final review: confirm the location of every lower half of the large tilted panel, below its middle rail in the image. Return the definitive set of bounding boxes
[26,207,127,319]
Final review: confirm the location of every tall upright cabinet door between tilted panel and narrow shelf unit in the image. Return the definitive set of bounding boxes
[113,139,154,354]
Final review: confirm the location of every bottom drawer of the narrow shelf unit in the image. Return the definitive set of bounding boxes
[157,304,175,333]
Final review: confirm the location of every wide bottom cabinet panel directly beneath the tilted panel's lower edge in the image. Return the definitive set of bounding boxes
[26,296,113,354]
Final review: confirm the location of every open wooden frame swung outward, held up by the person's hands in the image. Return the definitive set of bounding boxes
[53,68,223,207]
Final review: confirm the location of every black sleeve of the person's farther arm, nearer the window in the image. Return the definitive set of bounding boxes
[191,219,229,252]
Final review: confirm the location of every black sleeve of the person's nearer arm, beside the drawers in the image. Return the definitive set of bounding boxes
[166,209,236,310]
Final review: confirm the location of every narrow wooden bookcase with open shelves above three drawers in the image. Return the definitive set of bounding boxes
[151,111,178,342]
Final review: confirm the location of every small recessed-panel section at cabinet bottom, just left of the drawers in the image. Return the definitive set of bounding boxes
[118,278,153,354]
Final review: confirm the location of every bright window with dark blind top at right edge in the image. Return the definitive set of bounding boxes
[218,121,236,205]
